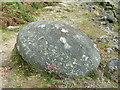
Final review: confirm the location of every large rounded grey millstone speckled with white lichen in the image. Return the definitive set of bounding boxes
[17,21,100,78]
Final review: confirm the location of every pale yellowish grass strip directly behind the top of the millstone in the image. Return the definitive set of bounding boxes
[36,5,107,39]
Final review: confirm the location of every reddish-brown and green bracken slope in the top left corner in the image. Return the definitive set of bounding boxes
[1,2,55,29]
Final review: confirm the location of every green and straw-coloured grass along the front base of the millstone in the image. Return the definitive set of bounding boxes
[3,45,117,88]
